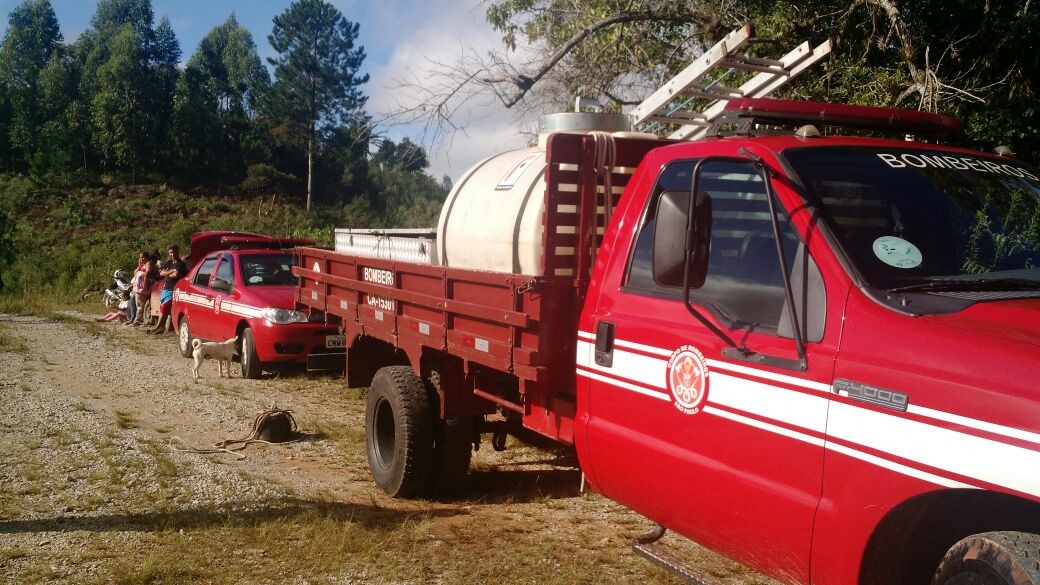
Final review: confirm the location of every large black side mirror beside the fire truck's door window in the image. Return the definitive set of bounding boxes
[653,190,711,288]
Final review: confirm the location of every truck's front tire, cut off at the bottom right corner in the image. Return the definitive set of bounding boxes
[932,532,1040,585]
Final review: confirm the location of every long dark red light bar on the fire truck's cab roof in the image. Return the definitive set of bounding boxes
[706,99,961,137]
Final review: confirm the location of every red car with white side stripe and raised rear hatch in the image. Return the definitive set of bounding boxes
[172,232,344,379]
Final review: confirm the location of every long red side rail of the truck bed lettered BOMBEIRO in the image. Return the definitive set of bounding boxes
[293,248,577,392]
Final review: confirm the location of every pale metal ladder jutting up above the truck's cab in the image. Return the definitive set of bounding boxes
[628,23,831,139]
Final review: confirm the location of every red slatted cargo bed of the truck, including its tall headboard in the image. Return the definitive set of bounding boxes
[293,134,662,442]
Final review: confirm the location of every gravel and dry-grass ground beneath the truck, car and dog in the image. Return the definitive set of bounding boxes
[0,313,772,584]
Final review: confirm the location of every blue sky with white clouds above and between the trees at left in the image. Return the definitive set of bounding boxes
[0,0,524,181]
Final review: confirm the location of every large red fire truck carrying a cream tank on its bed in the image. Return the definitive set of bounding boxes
[295,100,1040,585]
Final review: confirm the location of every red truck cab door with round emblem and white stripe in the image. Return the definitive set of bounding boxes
[578,160,836,582]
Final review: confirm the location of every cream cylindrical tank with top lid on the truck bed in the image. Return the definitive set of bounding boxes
[437,112,644,275]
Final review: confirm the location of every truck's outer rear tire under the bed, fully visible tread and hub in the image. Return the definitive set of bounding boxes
[365,365,434,498]
